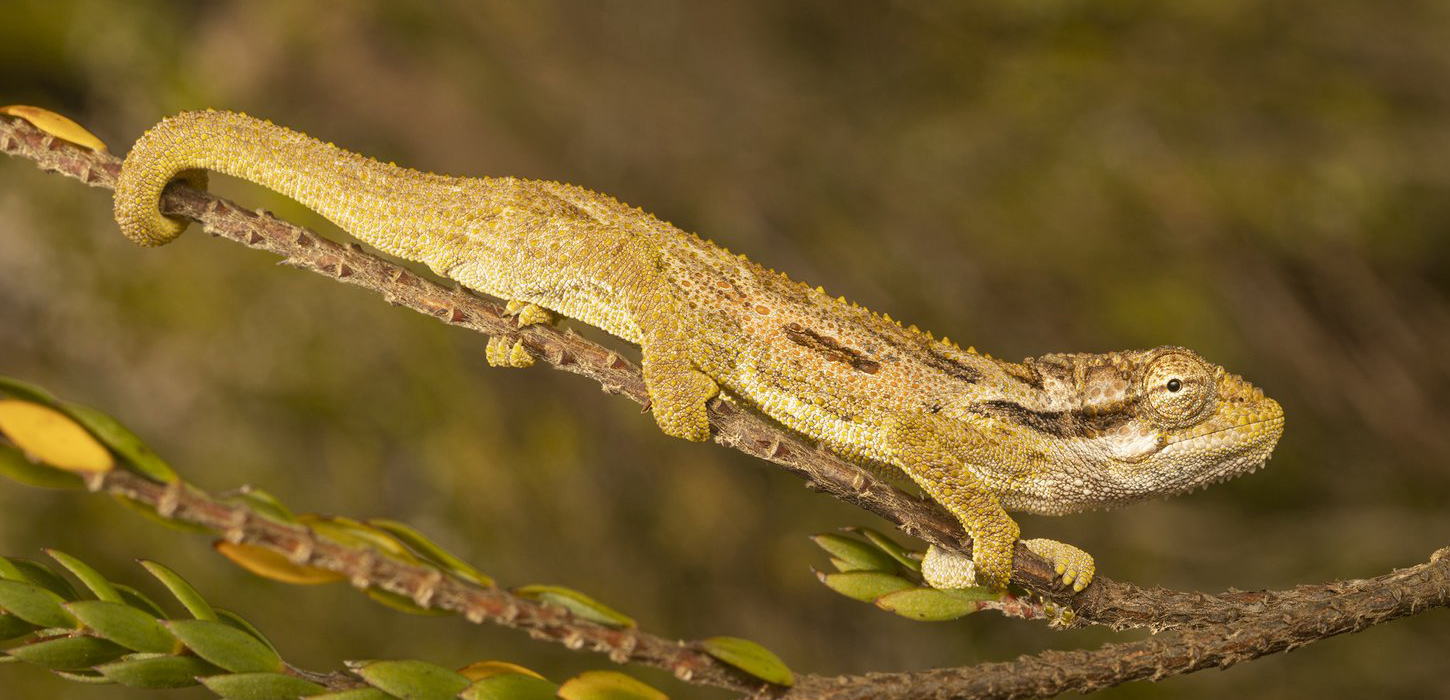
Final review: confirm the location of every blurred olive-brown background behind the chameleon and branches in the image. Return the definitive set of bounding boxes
[0,0,1450,700]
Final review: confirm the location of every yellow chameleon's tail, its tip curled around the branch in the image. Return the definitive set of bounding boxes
[115,110,464,271]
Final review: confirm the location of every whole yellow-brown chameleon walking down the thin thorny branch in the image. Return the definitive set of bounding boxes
[115,110,1283,590]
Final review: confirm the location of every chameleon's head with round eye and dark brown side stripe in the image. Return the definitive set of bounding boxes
[1005,346,1283,513]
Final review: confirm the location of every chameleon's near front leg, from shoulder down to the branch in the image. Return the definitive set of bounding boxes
[886,416,1021,590]
